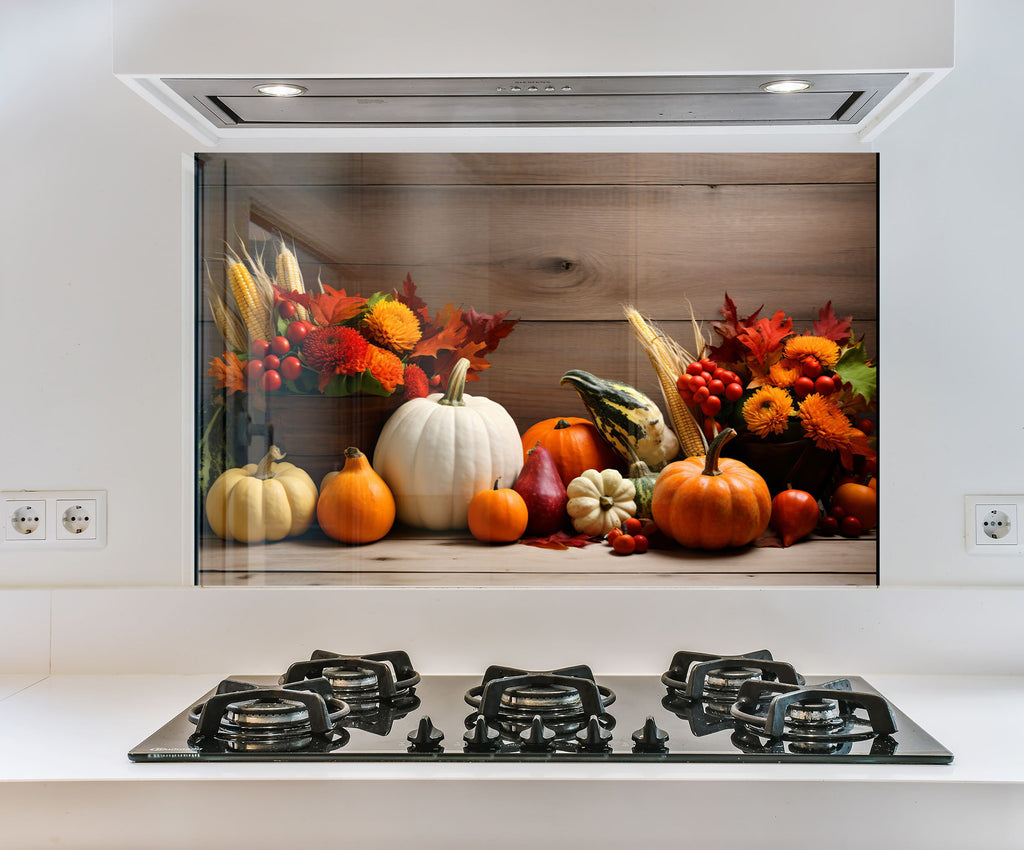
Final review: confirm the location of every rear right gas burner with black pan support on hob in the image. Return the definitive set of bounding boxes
[662,649,804,718]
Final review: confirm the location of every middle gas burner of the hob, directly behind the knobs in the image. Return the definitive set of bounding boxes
[466,665,615,735]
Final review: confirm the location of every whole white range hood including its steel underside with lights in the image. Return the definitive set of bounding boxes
[114,0,953,144]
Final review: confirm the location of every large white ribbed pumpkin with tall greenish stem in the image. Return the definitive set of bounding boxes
[373,357,522,530]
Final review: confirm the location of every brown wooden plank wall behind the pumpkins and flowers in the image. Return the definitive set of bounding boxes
[201,154,878,438]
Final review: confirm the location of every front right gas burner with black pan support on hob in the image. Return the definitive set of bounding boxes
[731,679,896,753]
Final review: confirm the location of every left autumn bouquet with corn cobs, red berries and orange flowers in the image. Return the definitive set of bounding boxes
[207,244,518,398]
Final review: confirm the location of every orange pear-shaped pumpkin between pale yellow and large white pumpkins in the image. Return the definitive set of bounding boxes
[316,448,395,543]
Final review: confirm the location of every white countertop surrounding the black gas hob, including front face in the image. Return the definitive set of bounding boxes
[0,674,1024,850]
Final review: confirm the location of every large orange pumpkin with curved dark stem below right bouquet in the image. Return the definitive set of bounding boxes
[651,428,771,549]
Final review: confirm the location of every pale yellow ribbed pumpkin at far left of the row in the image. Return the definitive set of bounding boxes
[206,445,316,543]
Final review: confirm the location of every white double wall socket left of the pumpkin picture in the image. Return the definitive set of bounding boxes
[0,490,106,549]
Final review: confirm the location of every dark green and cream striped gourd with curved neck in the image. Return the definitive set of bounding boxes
[559,369,679,470]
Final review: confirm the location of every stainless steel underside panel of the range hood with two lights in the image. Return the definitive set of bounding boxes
[163,73,907,129]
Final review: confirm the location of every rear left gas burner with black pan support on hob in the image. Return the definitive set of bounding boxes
[280,649,420,717]
